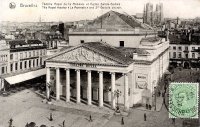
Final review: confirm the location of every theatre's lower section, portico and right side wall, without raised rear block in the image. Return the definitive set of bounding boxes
[46,38,169,109]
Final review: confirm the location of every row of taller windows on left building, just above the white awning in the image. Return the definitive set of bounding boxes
[10,58,43,72]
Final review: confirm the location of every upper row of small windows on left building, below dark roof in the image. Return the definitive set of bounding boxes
[10,50,46,60]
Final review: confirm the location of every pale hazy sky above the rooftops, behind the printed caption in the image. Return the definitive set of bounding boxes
[0,0,200,21]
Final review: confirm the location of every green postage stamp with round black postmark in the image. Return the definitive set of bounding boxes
[169,82,199,118]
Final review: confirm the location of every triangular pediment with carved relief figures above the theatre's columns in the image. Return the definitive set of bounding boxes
[48,46,120,65]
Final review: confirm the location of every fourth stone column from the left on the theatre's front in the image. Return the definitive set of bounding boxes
[76,70,81,103]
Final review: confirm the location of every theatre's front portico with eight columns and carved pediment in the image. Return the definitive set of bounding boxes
[46,43,133,109]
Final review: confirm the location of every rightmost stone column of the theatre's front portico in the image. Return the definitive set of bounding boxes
[124,73,129,110]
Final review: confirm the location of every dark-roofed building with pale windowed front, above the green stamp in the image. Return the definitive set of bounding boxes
[169,30,200,68]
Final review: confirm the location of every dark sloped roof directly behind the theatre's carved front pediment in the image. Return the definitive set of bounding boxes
[47,42,133,65]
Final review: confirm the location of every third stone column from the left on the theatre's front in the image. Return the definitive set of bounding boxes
[66,69,70,102]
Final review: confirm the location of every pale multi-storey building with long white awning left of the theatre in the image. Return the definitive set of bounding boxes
[0,40,46,89]
